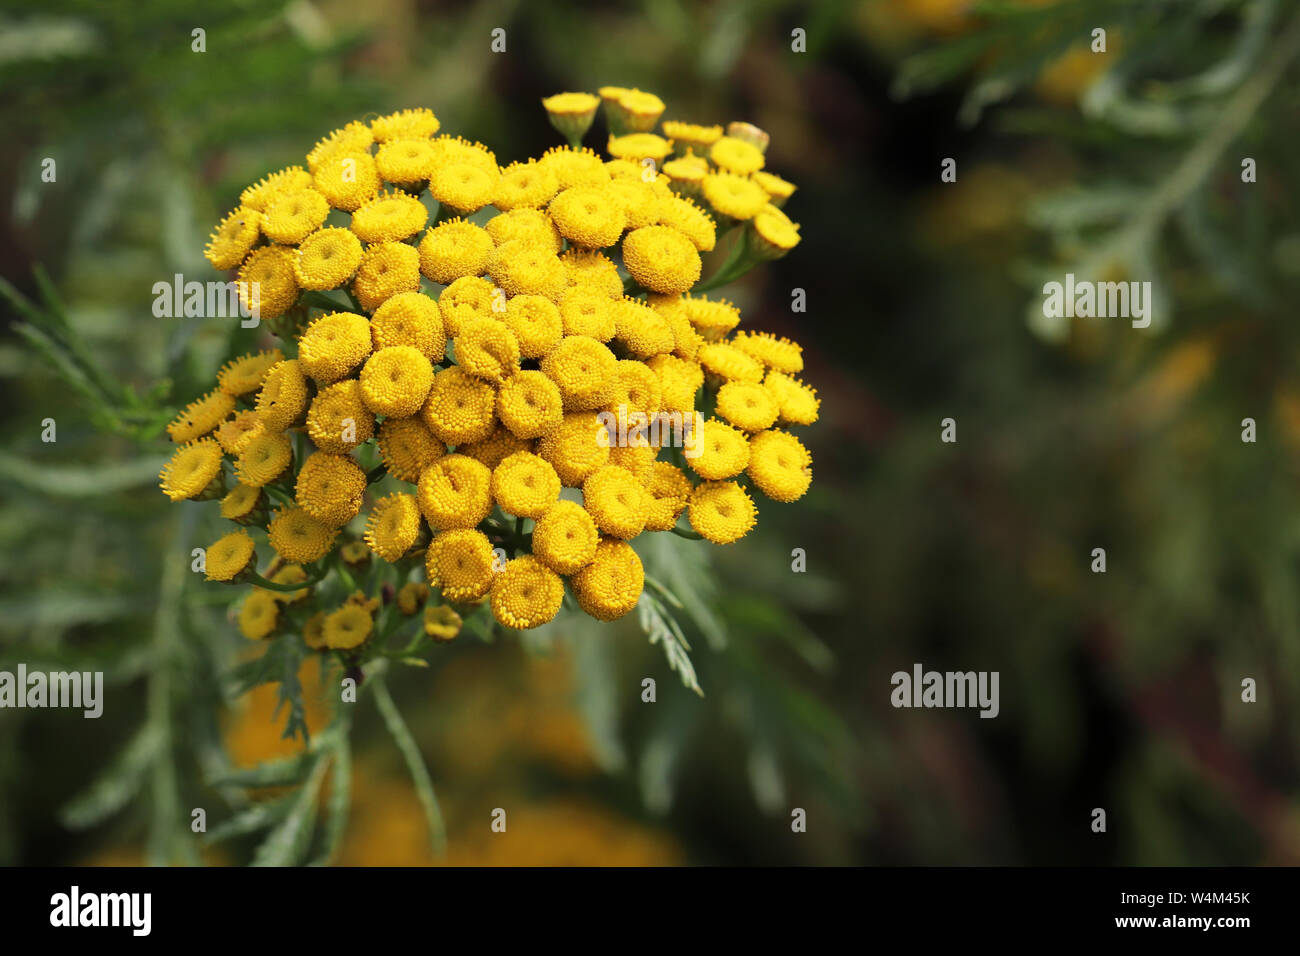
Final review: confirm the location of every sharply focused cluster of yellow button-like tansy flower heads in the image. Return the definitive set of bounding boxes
[160,87,819,661]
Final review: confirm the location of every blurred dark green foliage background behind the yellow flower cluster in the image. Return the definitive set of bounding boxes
[0,0,1300,865]
